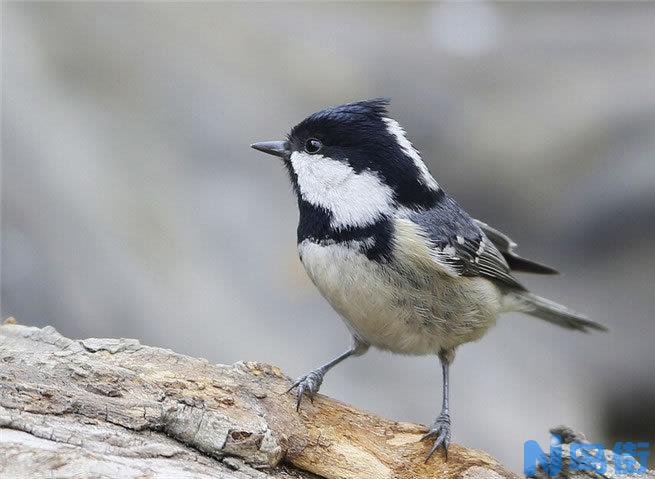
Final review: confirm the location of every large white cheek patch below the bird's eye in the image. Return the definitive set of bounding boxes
[291,151,395,228]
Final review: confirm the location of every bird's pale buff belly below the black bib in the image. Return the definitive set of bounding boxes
[298,241,501,354]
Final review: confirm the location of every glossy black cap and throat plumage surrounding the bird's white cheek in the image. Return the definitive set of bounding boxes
[286,98,444,262]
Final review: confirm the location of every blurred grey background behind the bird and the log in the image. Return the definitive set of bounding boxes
[1,2,655,471]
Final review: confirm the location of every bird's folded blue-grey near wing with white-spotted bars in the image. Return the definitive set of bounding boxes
[409,197,525,290]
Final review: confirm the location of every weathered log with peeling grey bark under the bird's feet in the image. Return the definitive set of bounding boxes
[0,324,644,479]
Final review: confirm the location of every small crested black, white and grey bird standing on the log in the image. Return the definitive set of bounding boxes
[251,98,607,461]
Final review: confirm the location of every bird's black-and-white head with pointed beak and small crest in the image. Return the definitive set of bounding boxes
[252,99,440,229]
